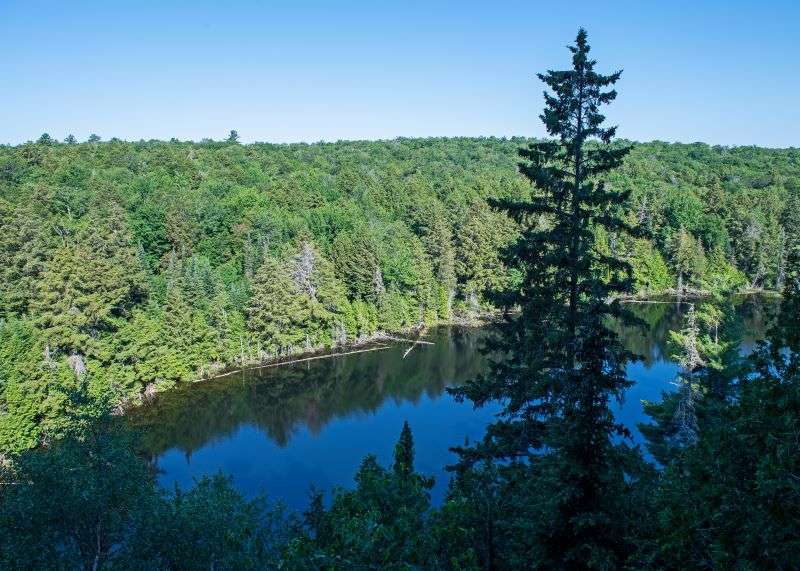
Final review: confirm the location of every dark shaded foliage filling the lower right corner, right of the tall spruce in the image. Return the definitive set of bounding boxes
[639,290,800,569]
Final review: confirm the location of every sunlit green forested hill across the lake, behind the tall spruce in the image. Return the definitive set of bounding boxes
[0,136,800,449]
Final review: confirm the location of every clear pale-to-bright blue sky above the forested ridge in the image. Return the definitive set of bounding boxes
[0,0,800,147]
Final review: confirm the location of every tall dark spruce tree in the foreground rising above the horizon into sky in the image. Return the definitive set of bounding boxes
[455,30,632,569]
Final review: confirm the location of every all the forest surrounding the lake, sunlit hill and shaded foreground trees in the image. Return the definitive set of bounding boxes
[0,30,800,569]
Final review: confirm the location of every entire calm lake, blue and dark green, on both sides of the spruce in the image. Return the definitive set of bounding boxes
[129,297,777,510]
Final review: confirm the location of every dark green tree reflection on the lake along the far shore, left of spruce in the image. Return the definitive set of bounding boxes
[133,328,485,455]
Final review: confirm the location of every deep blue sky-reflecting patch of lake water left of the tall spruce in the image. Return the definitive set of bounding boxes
[153,386,492,509]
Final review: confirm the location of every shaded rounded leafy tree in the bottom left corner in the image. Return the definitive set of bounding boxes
[0,408,157,570]
